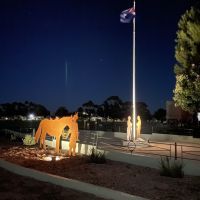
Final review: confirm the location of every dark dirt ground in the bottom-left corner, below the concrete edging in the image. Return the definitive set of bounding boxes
[0,168,109,200]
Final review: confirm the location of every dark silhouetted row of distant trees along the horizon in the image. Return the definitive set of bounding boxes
[0,96,166,121]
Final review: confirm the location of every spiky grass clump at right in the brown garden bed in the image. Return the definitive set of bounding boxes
[160,157,184,178]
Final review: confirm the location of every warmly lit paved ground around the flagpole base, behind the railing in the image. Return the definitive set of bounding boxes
[79,131,200,161]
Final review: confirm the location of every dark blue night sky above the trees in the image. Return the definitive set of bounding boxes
[0,0,197,112]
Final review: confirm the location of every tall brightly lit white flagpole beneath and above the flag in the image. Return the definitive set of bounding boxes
[132,0,136,140]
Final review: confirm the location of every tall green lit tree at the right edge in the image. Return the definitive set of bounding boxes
[173,4,200,119]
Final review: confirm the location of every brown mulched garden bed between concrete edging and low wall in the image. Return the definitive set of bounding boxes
[0,134,200,200]
